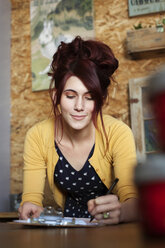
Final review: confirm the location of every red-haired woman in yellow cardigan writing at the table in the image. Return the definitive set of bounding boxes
[19,37,137,224]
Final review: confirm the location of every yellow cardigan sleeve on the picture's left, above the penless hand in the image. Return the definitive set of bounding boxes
[21,124,46,206]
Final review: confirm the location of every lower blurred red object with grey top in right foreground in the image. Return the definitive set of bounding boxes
[135,154,165,236]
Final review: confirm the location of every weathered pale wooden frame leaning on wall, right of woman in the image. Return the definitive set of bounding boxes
[129,77,158,160]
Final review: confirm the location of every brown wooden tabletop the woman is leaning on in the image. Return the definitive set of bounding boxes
[0,219,165,248]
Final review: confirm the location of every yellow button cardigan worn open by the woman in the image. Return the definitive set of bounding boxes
[21,115,137,208]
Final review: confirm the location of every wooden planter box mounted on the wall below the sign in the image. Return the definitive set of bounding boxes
[126,28,165,58]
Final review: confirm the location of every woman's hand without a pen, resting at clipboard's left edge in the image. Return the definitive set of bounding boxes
[18,202,43,220]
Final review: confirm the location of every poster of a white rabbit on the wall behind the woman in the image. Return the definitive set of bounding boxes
[30,0,94,91]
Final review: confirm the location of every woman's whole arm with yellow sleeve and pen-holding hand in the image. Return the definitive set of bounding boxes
[88,121,138,224]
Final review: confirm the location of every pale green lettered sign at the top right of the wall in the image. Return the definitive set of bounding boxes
[128,0,165,17]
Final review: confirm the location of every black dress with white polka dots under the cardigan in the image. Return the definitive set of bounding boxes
[54,143,107,218]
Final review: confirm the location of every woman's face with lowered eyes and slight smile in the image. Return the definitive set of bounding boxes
[60,76,95,130]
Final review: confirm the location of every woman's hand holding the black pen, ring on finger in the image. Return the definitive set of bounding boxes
[88,195,121,224]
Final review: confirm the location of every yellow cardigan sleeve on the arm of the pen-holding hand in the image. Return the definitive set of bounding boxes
[112,123,137,202]
